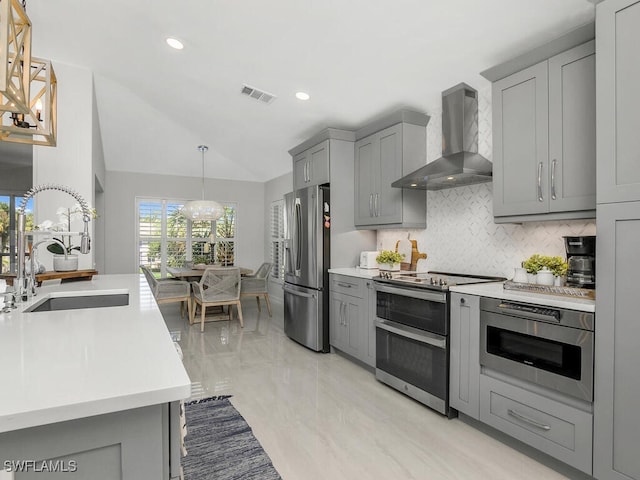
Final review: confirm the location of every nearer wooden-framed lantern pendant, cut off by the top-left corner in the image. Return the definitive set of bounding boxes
[0,0,31,114]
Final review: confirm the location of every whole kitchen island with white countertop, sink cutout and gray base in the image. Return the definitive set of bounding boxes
[0,275,191,479]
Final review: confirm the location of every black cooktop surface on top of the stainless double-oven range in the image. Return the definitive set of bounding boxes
[374,270,506,291]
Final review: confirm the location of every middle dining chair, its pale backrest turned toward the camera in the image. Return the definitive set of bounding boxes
[190,267,244,332]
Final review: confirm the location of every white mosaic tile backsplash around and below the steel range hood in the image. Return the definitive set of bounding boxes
[377,86,596,278]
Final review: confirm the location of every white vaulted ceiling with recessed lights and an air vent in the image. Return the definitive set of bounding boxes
[18,0,594,181]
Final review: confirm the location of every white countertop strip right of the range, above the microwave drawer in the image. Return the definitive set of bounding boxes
[449,282,596,312]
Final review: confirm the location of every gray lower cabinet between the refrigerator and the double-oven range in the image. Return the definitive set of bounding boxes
[329,274,375,367]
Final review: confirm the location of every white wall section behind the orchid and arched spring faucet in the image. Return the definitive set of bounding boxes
[33,61,104,270]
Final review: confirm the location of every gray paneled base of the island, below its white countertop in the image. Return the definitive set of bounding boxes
[0,404,180,480]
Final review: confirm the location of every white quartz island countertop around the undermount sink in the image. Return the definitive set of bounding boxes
[0,274,191,433]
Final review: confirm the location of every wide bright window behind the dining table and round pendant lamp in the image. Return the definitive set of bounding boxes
[136,198,236,277]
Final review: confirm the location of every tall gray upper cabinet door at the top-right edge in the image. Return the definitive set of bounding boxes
[596,0,640,203]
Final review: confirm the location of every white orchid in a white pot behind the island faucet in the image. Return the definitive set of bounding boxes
[37,203,97,272]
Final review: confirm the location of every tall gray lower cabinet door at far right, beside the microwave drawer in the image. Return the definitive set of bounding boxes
[593,201,640,480]
